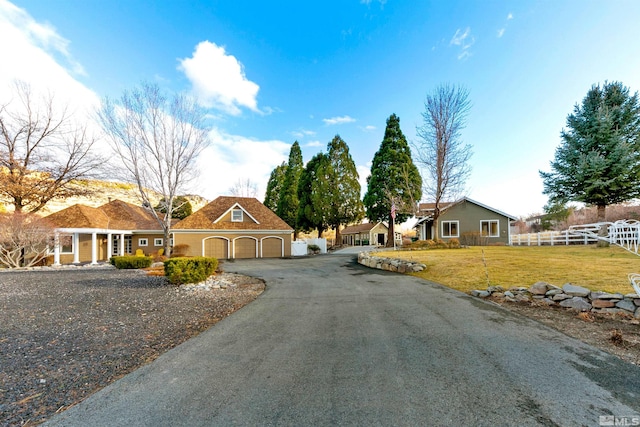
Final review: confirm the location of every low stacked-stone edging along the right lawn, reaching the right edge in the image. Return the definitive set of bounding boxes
[471,282,640,319]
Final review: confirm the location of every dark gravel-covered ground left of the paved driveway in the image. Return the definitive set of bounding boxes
[0,268,264,426]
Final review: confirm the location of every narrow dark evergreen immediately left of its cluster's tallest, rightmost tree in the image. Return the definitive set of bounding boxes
[297,153,329,237]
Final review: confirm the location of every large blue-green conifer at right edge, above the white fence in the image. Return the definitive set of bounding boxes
[540,82,640,221]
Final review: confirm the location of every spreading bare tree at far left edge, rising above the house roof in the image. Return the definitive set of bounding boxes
[0,81,103,212]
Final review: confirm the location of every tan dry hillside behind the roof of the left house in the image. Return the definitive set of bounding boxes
[0,180,209,216]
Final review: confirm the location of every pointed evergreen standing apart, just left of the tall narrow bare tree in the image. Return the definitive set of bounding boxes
[364,114,422,245]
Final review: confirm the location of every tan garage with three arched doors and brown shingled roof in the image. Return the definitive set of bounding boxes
[172,196,293,259]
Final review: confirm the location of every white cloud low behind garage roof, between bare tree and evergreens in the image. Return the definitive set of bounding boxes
[190,129,291,199]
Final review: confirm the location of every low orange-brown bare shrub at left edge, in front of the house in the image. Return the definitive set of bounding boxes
[0,212,54,268]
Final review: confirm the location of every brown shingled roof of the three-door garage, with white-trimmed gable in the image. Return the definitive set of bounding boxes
[173,196,293,231]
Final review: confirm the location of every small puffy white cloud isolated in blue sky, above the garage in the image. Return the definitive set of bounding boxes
[178,41,260,115]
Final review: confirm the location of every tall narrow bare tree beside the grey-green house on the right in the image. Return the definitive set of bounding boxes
[414,84,472,237]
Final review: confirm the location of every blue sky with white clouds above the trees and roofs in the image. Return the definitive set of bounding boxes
[0,0,640,221]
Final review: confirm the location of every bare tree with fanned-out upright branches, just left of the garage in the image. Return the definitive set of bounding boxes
[98,83,208,255]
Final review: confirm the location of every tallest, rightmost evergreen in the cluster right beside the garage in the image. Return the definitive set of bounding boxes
[319,135,364,243]
